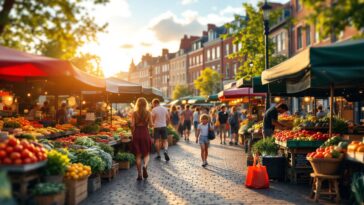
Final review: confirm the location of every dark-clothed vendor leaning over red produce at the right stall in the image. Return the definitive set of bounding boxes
[263,103,288,138]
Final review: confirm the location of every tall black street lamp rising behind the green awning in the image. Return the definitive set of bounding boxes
[262,0,272,110]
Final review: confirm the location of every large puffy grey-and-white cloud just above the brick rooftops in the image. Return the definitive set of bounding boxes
[149,11,204,42]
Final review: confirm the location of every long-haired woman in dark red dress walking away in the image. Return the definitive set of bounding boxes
[131,98,153,181]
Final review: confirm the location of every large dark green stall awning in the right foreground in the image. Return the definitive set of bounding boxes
[262,39,364,93]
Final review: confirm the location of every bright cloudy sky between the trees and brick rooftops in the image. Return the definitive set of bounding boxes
[81,0,288,77]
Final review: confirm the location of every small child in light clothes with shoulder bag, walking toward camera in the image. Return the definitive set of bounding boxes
[197,114,214,167]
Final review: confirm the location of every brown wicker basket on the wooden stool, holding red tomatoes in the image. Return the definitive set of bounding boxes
[307,158,342,175]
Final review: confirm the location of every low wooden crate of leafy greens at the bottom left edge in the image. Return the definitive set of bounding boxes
[32,183,65,205]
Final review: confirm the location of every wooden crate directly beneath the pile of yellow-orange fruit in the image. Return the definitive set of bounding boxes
[65,178,88,205]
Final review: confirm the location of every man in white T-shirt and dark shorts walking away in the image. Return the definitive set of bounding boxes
[152,99,169,161]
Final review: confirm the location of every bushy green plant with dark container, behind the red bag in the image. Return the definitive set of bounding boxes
[253,137,286,180]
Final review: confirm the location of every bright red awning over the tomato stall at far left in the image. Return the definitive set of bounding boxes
[0,46,73,81]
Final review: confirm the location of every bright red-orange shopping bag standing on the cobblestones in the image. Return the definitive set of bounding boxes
[245,159,269,189]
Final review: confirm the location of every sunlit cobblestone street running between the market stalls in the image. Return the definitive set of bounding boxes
[82,140,322,205]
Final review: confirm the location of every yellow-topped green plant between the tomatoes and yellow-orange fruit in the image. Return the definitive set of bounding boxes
[44,149,70,183]
